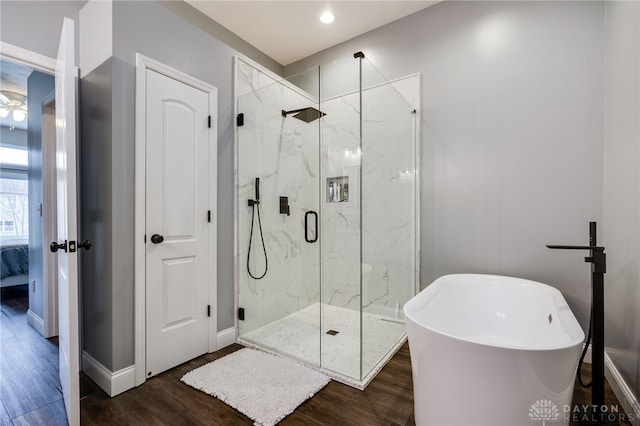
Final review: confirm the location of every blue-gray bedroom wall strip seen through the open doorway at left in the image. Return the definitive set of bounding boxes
[27,71,55,318]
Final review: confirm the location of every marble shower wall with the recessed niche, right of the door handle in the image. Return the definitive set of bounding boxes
[321,74,419,317]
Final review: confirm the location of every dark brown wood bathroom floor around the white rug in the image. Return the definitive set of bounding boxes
[81,345,628,426]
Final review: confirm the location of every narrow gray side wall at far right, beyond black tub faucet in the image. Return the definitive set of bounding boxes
[603,1,640,399]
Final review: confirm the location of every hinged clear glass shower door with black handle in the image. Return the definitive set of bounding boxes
[236,61,320,366]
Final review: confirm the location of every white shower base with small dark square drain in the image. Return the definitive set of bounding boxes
[238,303,407,389]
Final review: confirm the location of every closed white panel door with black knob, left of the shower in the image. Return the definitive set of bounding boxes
[146,70,211,377]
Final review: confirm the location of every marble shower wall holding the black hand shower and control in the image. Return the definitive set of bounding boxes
[236,59,320,336]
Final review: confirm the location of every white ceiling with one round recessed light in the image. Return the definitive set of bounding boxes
[185,0,440,66]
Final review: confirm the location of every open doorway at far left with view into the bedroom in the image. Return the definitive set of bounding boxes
[0,57,64,423]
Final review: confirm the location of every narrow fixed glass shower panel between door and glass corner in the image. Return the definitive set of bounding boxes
[320,57,362,381]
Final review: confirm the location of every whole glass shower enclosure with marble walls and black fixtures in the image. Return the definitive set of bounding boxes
[235,52,419,389]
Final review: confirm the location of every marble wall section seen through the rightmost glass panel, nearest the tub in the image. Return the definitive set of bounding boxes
[362,80,419,320]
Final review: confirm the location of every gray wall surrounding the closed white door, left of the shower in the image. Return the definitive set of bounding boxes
[75,1,278,371]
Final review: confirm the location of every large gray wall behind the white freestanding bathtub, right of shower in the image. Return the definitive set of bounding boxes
[285,1,604,326]
